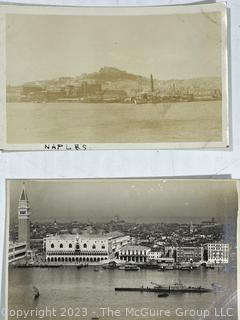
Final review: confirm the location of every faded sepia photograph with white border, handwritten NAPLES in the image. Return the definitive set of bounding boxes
[0,3,229,150]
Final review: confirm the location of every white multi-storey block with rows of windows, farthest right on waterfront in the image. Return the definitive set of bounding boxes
[204,243,229,264]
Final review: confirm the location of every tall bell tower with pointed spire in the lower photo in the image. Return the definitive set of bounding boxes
[18,184,30,249]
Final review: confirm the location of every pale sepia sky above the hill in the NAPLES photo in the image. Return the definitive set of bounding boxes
[6,13,221,84]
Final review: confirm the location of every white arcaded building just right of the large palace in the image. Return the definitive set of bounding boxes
[116,244,151,263]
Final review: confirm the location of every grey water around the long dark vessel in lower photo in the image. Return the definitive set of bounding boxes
[9,267,237,320]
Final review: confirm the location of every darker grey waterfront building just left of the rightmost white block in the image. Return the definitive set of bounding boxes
[176,247,203,262]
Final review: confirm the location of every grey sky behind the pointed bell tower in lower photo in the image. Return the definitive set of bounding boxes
[9,179,237,223]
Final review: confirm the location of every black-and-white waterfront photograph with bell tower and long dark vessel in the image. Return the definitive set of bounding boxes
[6,179,238,320]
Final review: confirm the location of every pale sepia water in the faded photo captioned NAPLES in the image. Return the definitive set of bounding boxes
[7,101,222,143]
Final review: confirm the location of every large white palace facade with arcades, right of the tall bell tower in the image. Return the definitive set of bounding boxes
[44,234,109,264]
